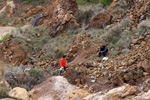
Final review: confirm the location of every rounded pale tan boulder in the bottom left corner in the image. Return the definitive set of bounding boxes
[9,87,29,100]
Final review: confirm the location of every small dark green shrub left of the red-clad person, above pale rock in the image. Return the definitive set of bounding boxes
[29,68,44,80]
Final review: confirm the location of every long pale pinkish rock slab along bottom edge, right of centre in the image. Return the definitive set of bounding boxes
[83,84,137,100]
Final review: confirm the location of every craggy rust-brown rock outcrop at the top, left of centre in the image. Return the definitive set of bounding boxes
[39,0,78,36]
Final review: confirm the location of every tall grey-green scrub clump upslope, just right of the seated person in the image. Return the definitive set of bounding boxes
[105,18,132,48]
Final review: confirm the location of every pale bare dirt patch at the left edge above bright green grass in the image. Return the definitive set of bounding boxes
[0,26,15,40]
